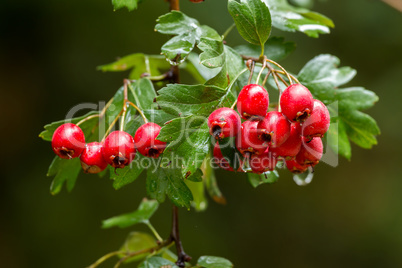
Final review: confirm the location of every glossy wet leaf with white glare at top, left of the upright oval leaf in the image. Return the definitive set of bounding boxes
[155,11,202,64]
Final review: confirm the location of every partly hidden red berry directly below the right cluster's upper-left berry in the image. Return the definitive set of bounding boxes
[236,120,268,156]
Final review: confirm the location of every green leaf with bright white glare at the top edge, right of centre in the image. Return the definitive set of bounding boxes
[263,0,334,37]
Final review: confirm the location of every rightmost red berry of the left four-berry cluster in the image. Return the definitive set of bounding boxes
[134,122,166,158]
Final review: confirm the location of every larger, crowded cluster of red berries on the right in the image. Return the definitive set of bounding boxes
[208,84,330,174]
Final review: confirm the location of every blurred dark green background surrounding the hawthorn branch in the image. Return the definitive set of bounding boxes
[0,0,402,268]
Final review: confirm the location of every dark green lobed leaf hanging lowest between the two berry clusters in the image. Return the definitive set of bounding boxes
[146,164,193,208]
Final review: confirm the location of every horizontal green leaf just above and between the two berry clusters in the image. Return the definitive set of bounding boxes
[156,84,234,117]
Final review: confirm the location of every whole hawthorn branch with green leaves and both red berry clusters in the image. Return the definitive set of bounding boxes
[40,0,380,268]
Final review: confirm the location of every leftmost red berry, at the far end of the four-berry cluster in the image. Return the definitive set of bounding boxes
[52,123,85,159]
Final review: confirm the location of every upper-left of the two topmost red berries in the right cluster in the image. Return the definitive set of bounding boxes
[237,84,269,120]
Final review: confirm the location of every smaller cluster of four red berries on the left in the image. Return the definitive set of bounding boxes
[52,123,166,174]
